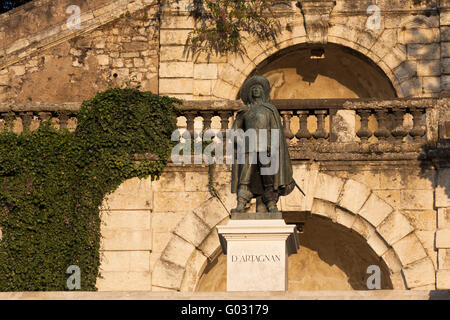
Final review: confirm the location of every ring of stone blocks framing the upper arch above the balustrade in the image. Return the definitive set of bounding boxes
[212,22,415,100]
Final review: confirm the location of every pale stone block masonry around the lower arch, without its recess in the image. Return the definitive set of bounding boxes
[98,163,450,291]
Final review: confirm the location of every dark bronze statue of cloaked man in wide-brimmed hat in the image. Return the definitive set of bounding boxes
[231,76,295,213]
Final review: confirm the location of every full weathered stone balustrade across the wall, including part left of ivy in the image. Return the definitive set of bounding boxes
[0,98,446,159]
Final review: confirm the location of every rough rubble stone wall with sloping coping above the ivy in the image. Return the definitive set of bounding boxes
[0,1,159,103]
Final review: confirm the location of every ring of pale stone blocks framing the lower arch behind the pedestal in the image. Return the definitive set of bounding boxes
[152,169,435,291]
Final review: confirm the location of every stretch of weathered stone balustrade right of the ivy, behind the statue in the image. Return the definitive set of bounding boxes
[178,98,446,160]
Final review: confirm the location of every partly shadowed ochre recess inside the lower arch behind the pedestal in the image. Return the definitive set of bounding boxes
[197,216,392,291]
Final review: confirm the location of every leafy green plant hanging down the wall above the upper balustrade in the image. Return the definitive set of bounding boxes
[186,0,281,56]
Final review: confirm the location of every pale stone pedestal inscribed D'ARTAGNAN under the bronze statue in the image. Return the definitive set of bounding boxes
[217,217,299,291]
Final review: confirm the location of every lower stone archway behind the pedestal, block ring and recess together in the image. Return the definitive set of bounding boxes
[152,170,435,291]
